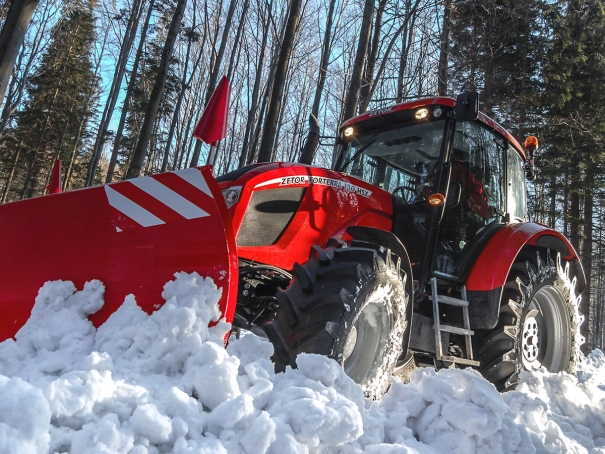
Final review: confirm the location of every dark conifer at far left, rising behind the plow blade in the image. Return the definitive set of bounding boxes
[0,0,98,200]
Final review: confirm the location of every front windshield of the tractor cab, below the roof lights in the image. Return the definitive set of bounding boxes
[342,121,444,203]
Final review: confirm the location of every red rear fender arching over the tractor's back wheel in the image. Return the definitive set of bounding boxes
[466,222,584,291]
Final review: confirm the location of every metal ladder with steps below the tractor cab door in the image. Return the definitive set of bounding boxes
[429,278,479,366]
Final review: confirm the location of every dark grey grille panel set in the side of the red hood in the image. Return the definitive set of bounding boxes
[237,188,305,246]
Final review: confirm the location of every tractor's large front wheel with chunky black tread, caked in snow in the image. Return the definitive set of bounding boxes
[264,242,412,399]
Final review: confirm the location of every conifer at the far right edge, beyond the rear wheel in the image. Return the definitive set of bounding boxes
[544,0,605,349]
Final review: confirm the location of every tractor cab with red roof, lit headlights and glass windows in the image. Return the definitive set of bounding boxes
[336,95,526,292]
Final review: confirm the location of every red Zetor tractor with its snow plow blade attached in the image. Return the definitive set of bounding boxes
[0,93,585,397]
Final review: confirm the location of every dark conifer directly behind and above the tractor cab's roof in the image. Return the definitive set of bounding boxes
[449,0,547,130]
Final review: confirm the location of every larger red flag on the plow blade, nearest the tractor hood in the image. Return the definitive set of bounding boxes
[193,76,230,144]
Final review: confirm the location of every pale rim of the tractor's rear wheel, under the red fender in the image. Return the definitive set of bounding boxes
[521,285,571,372]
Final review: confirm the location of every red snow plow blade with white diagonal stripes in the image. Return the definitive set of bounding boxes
[0,166,238,341]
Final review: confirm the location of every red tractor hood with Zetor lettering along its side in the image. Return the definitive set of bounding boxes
[219,163,393,269]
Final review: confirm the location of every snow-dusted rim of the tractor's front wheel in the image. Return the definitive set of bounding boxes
[343,302,393,383]
